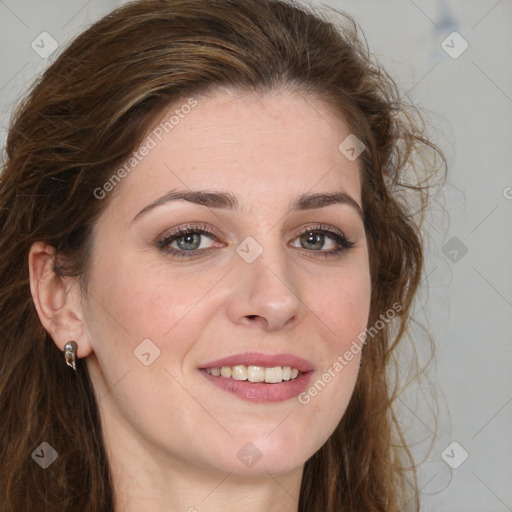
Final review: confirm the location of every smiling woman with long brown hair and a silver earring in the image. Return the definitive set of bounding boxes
[0,0,444,512]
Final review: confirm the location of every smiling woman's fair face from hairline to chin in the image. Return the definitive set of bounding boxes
[84,90,370,475]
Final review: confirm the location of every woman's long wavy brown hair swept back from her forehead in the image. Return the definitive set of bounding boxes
[0,0,443,512]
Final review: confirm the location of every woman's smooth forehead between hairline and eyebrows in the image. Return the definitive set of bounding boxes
[104,90,361,220]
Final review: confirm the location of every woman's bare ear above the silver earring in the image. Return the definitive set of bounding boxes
[28,242,92,357]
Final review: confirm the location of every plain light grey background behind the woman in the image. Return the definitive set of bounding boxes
[0,0,512,512]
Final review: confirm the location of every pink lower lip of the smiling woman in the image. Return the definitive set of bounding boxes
[201,370,313,403]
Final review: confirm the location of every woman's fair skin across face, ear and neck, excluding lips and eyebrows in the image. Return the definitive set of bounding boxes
[29,89,370,512]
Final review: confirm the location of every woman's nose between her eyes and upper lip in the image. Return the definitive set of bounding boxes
[227,244,305,331]
